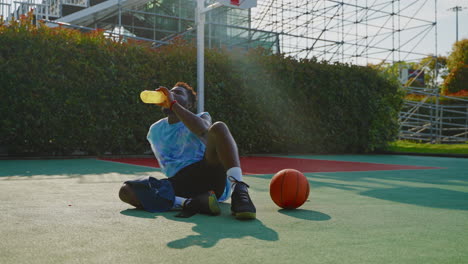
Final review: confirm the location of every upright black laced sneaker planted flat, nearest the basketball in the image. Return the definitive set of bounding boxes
[229,177,257,220]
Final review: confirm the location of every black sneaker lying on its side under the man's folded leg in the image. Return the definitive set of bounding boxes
[176,191,221,218]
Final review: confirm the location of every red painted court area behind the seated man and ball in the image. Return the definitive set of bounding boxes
[98,157,441,175]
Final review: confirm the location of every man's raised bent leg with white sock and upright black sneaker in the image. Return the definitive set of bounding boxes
[205,122,256,219]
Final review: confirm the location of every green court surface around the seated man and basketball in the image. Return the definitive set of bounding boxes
[0,155,468,264]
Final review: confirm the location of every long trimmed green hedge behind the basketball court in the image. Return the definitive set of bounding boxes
[0,16,402,155]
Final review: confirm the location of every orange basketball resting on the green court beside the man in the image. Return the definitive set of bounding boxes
[270,169,310,209]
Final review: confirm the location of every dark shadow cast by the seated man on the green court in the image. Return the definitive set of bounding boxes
[120,204,278,249]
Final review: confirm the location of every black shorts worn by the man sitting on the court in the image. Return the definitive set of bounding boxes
[168,159,226,198]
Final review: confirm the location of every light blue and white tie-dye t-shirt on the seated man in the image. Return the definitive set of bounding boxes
[147,112,211,177]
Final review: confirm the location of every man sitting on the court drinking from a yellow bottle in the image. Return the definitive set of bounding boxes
[119,82,256,219]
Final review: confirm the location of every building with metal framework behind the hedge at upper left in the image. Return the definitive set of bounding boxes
[0,0,279,53]
